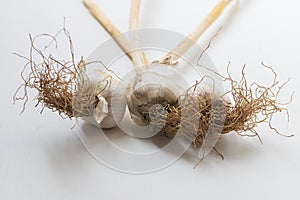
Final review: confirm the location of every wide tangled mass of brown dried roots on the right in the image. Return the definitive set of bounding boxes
[150,64,293,147]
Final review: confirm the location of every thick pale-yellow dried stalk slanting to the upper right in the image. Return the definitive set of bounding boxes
[160,0,239,65]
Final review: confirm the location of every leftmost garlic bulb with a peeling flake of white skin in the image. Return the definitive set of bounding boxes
[73,69,125,128]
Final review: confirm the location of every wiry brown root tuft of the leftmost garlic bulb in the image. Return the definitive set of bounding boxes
[13,27,111,118]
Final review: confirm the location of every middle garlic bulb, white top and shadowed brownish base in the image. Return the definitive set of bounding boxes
[127,63,187,127]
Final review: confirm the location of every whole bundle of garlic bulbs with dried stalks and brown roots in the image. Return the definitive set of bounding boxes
[15,0,292,159]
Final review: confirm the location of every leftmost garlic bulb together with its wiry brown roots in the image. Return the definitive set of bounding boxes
[14,27,124,128]
